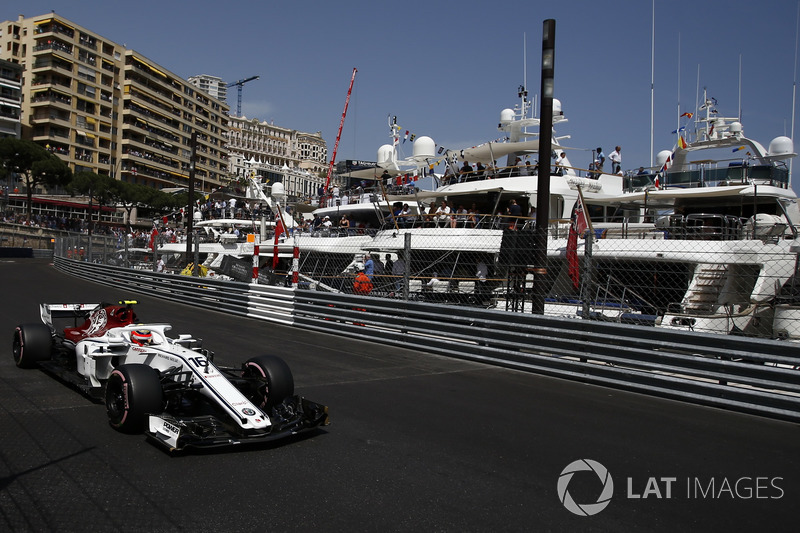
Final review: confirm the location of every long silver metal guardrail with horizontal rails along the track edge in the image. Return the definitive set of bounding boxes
[54,257,800,422]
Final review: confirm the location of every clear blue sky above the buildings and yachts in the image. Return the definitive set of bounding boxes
[0,0,800,174]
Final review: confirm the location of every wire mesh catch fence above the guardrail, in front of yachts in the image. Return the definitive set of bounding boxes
[55,211,800,338]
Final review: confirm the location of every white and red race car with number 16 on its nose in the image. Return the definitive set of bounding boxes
[13,300,329,451]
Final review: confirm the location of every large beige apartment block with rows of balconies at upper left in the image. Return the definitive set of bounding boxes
[0,13,230,191]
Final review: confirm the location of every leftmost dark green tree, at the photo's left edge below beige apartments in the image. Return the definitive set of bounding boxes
[0,137,72,223]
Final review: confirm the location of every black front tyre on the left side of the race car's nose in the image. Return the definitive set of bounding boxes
[106,364,164,433]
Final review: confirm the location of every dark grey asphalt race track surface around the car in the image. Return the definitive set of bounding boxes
[0,259,800,532]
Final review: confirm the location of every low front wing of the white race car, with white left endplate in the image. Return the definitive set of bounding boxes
[145,396,330,451]
